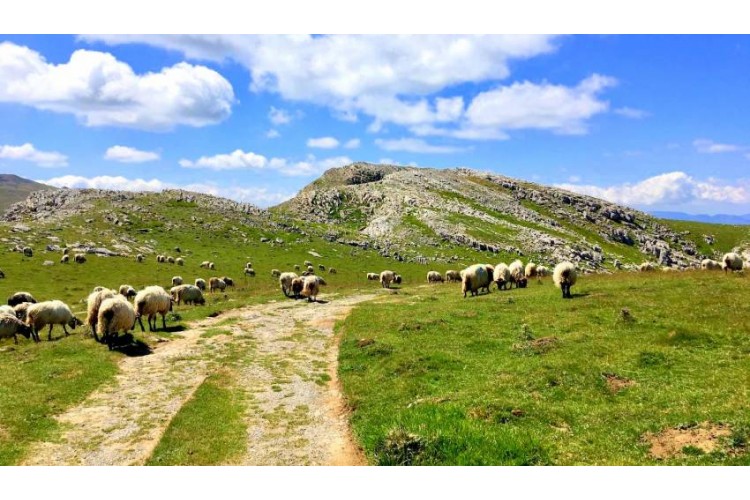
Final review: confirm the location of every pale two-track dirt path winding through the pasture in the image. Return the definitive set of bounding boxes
[23,295,374,465]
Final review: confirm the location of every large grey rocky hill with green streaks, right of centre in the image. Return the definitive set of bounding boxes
[272,163,702,270]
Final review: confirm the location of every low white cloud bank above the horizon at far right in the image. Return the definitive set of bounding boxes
[557,171,750,206]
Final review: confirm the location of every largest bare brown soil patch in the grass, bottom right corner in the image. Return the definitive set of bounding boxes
[643,422,732,459]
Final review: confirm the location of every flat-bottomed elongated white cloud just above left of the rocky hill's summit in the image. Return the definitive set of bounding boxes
[179,149,352,177]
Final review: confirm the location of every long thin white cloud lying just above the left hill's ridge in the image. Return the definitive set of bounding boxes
[37,175,294,207]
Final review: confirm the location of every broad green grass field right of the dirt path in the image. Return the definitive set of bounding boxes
[339,272,750,465]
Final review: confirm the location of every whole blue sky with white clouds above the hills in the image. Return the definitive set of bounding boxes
[0,35,750,213]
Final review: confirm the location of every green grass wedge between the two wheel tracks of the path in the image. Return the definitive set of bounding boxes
[146,371,247,465]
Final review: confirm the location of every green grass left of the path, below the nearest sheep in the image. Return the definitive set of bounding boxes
[0,332,121,465]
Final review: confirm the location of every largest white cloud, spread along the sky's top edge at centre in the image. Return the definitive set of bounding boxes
[82,35,556,132]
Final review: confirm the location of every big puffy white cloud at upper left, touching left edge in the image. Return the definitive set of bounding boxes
[0,42,234,130]
